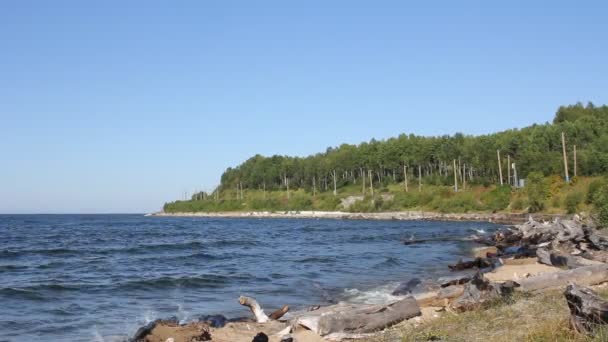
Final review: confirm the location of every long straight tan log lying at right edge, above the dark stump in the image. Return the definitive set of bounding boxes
[517,264,608,292]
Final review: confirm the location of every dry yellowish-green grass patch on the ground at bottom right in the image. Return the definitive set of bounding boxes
[370,289,608,342]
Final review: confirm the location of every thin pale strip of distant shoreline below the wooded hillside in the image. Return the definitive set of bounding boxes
[146,211,566,225]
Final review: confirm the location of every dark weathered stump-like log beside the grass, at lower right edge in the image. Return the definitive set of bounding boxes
[564,284,608,334]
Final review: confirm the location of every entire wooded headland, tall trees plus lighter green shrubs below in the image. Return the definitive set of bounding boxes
[163,103,608,226]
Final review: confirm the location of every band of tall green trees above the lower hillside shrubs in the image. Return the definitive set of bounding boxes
[219,103,608,191]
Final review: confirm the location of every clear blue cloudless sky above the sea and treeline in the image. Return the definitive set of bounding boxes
[0,0,608,213]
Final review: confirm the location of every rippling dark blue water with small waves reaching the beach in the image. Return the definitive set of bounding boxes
[0,215,498,341]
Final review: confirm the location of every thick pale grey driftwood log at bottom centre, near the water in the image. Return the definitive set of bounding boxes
[296,297,421,336]
